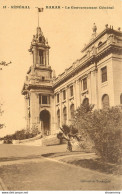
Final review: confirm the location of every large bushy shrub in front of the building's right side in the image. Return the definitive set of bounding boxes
[74,105,122,163]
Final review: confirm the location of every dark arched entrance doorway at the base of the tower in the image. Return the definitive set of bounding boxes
[40,110,50,135]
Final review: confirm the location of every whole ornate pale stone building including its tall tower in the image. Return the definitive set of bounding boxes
[22,24,122,135]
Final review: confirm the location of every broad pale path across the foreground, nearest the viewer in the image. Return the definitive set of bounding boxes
[0,158,120,190]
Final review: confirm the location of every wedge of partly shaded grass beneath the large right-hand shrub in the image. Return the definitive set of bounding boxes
[42,152,122,175]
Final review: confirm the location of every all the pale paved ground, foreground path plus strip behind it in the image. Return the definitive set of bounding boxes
[0,145,121,190]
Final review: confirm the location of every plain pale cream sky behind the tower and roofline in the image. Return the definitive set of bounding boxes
[0,0,122,137]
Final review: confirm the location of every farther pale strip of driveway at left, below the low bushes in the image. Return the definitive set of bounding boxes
[0,144,67,161]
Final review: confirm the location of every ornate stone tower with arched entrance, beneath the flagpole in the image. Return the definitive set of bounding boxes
[22,27,54,135]
